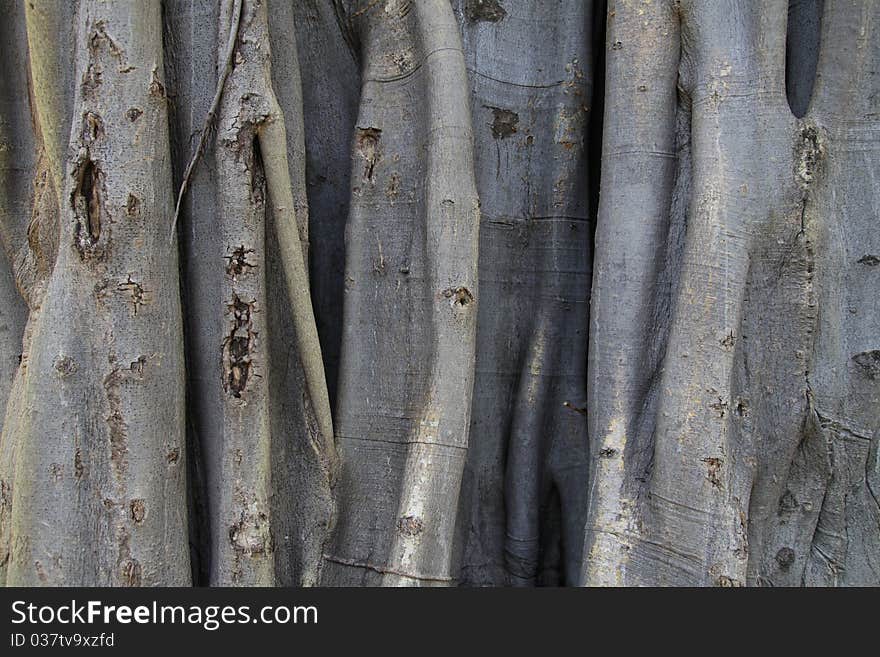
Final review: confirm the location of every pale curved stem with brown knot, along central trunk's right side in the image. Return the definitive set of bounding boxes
[383,2,479,585]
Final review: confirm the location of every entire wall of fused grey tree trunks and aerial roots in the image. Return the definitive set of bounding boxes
[0,0,880,586]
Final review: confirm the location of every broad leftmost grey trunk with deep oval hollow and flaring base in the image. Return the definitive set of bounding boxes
[4,0,190,586]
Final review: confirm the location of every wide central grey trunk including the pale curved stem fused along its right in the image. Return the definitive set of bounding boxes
[324,0,479,585]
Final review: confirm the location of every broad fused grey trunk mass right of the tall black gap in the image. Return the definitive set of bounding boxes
[584,2,880,586]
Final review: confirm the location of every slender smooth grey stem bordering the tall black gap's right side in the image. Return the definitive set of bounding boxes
[583,2,679,585]
